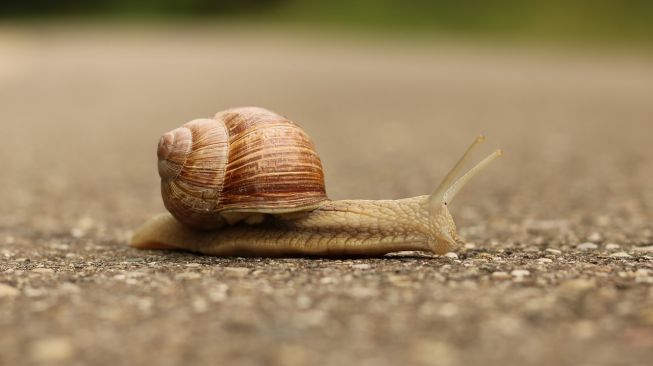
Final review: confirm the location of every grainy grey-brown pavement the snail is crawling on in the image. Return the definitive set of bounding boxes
[0,25,653,365]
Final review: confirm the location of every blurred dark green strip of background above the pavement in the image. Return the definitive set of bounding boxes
[0,0,653,45]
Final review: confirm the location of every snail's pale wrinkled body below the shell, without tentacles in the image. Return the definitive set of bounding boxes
[131,196,461,256]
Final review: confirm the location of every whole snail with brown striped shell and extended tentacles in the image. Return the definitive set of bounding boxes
[130,107,501,257]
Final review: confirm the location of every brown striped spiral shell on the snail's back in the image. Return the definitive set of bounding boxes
[157,107,327,229]
